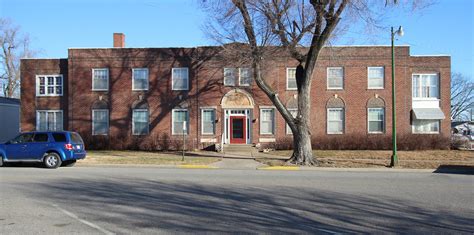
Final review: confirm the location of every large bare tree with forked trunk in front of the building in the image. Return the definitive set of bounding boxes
[204,0,426,165]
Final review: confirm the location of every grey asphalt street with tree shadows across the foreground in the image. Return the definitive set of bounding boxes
[0,167,474,234]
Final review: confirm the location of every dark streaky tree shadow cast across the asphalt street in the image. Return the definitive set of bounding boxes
[23,177,474,234]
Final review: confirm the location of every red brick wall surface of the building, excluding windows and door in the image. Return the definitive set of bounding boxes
[21,46,451,149]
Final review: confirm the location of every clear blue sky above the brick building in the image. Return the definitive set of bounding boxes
[0,0,474,79]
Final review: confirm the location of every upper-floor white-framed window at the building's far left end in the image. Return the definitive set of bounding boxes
[36,74,63,96]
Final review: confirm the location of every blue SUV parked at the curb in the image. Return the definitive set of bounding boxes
[0,131,86,168]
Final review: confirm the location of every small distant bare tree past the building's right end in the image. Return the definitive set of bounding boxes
[451,73,474,121]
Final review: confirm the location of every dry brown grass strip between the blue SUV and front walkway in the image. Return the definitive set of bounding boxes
[78,151,219,166]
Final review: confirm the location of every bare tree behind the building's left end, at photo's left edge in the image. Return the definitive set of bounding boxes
[0,18,33,97]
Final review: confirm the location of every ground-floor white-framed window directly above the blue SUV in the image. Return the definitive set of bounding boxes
[36,110,63,131]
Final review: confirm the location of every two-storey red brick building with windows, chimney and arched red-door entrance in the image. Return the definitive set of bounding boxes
[21,34,451,149]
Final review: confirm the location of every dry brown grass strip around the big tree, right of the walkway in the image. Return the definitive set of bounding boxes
[257,150,474,169]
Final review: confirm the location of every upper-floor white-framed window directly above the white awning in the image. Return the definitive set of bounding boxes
[412,73,439,99]
